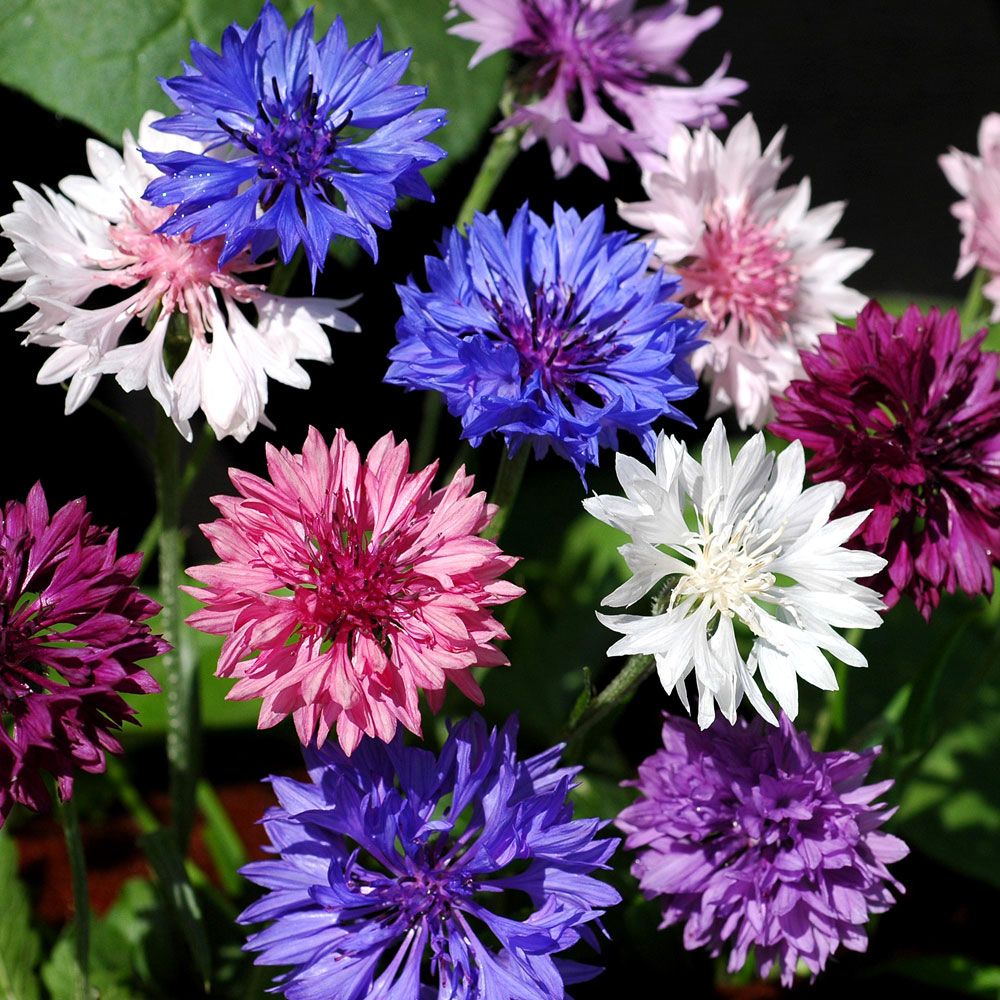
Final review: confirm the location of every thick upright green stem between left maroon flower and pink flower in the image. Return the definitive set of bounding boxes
[156,415,201,855]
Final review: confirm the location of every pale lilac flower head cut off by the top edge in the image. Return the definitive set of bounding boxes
[451,0,746,180]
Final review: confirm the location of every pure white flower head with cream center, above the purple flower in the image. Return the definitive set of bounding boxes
[583,420,885,729]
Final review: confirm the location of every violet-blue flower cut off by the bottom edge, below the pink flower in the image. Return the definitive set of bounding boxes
[240,715,621,1000]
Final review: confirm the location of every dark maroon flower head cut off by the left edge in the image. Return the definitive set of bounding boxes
[0,485,169,826]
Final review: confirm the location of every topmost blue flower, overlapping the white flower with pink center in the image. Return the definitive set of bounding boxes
[143,0,445,282]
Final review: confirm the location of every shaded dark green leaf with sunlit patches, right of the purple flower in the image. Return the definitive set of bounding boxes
[846,595,1000,886]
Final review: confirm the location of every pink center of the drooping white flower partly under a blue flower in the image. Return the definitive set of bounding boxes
[106,202,263,338]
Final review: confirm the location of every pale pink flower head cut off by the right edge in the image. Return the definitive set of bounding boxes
[938,114,1000,323]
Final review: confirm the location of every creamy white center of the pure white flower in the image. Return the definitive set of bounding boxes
[668,494,783,630]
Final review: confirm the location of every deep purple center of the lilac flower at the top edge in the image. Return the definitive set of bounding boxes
[516,0,644,89]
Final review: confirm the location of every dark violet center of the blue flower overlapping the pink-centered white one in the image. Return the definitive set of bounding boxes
[219,74,352,216]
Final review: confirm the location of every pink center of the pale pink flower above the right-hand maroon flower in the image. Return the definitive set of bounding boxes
[677,206,800,344]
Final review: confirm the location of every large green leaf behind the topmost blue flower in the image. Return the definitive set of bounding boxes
[0,0,505,173]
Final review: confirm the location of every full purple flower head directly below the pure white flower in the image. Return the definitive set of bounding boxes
[617,716,908,986]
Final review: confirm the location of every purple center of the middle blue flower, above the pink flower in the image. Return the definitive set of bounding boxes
[486,284,628,405]
